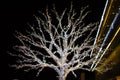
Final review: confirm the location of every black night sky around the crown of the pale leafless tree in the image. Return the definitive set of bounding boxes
[0,0,106,80]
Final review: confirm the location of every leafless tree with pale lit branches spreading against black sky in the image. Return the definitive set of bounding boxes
[12,6,98,80]
